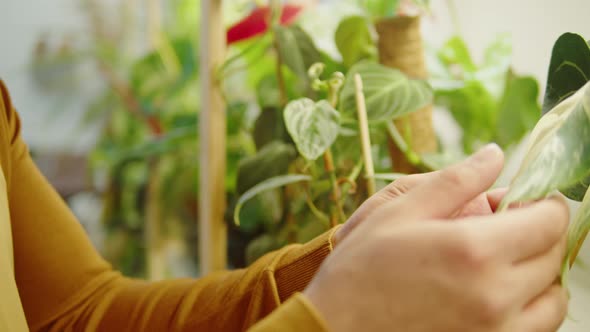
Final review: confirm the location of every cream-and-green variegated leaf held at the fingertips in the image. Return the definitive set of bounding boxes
[502,83,590,208]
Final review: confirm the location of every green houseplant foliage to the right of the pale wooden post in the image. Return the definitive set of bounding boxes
[229,1,540,262]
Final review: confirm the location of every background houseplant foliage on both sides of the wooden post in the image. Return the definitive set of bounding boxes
[35,0,540,276]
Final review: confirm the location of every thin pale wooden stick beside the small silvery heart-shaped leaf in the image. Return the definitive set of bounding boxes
[354,74,376,196]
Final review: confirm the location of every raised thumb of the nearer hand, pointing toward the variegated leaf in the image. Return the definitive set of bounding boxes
[395,144,504,219]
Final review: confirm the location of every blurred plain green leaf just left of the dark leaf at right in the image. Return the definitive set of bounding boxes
[496,77,541,146]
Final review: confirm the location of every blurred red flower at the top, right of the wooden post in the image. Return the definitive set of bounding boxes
[227,5,303,45]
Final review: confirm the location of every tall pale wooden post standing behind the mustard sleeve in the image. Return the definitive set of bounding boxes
[199,0,227,274]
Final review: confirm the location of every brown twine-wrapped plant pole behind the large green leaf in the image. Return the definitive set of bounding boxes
[376,16,437,173]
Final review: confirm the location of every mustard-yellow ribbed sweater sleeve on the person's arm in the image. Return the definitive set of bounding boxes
[0,82,334,331]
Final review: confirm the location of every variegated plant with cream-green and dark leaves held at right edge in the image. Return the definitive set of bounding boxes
[500,33,590,282]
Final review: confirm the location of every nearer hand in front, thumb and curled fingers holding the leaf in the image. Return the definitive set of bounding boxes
[304,145,568,332]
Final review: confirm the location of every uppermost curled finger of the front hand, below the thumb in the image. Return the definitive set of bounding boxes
[468,196,569,263]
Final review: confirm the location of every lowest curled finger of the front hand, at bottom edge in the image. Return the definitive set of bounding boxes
[510,285,568,332]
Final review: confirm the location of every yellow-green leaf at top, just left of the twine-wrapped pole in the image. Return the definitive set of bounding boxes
[335,16,377,67]
